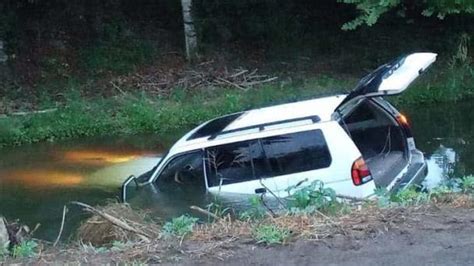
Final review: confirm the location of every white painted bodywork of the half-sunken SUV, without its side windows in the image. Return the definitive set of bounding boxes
[120,53,436,202]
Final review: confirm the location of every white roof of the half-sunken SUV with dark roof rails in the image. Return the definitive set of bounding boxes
[170,95,346,153]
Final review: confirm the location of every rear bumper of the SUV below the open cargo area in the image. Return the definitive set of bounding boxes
[390,150,428,192]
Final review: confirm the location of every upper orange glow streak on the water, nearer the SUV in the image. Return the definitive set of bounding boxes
[64,150,142,165]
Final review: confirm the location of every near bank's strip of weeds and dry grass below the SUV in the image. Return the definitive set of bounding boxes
[0,176,474,263]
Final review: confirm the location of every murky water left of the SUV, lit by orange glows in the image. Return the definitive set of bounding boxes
[0,136,168,239]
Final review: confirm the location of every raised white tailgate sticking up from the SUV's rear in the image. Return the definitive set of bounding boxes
[335,53,437,112]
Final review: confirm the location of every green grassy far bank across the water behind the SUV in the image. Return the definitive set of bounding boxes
[0,62,474,150]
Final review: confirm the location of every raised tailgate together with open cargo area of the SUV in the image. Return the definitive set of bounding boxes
[334,53,436,187]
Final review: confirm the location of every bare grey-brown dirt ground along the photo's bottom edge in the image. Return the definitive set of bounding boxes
[7,206,474,265]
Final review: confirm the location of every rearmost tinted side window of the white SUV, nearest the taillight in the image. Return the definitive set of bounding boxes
[262,130,331,176]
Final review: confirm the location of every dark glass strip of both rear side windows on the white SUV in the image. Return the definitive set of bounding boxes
[206,130,331,187]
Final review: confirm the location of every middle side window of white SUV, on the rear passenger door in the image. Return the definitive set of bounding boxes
[206,140,267,187]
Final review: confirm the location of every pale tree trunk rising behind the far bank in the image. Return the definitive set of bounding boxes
[181,0,197,61]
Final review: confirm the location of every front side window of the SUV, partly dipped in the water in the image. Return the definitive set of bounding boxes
[156,151,205,191]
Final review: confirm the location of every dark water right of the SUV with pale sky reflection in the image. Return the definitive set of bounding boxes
[400,101,474,188]
